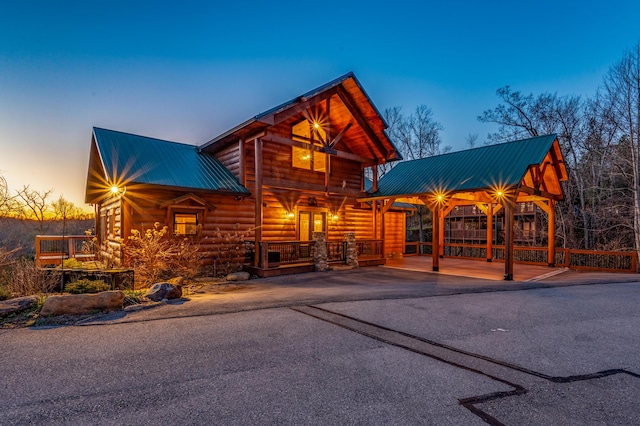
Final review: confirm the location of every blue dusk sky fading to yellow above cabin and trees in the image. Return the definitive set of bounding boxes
[0,0,640,205]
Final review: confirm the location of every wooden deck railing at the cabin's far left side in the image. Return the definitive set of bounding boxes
[36,235,95,268]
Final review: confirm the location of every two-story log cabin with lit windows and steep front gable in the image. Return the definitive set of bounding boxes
[86,73,405,275]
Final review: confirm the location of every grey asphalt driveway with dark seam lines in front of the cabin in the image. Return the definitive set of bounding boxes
[0,267,640,425]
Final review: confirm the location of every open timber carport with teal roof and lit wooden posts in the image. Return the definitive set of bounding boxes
[360,134,568,280]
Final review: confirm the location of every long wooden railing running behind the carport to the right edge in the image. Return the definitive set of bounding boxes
[404,242,637,272]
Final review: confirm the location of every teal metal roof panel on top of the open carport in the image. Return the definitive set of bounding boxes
[372,134,556,198]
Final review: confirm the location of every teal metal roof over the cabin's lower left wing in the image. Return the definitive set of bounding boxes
[93,127,249,194]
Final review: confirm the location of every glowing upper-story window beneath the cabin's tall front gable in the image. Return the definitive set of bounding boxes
[291,120,327,172]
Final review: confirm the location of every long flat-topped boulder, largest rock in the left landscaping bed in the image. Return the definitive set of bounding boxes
[40,290,124,316]
